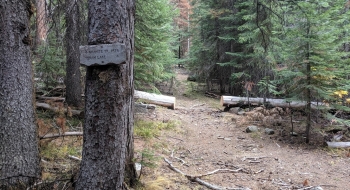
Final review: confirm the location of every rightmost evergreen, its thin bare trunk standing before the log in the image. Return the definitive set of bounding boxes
[280,0,348,142]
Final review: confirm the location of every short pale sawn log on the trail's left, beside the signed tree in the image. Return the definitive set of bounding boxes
[134,90,176,109]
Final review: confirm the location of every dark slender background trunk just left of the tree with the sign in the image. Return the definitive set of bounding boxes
[65,0,82,107]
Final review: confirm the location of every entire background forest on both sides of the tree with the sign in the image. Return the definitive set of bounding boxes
[32,0,350,137]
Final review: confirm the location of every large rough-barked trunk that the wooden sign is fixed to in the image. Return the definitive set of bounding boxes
[76,0,136,190]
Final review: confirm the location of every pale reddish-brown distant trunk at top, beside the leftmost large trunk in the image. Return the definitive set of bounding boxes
[35,0,48,47]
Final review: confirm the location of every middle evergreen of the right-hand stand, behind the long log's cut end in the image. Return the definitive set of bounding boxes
[221,0,281,98]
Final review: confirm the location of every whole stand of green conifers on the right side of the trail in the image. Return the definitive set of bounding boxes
[190,0,349,142]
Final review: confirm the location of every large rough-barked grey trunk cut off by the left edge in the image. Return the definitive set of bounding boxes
[0,0,40,189]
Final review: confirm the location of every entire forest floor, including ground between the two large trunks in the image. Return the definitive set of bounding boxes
[34,68,350,190]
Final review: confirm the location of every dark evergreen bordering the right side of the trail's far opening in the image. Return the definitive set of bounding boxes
[190,0,235,93]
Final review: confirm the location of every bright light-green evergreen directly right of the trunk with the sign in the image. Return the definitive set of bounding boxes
[135,0,175,90]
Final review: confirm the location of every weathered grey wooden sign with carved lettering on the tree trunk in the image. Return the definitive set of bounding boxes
[79,43,126,66]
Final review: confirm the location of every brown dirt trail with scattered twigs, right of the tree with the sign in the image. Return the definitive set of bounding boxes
[135,69,350,190]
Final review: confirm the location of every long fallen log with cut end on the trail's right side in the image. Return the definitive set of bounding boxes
[220,96,327,108]
